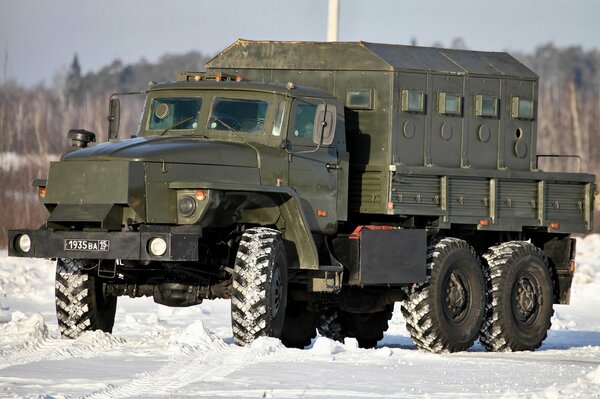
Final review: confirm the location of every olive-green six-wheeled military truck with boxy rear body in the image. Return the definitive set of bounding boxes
[9,40,595,352]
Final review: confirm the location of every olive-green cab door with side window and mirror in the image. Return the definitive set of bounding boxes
[287,99,340,234]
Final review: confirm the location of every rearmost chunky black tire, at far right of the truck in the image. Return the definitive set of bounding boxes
[479,241,554,352]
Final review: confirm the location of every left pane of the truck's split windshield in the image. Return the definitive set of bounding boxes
[148,97,202,131]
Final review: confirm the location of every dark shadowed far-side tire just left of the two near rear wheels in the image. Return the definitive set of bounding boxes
[340,305,394,349]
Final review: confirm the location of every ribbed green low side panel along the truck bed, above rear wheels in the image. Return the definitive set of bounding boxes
[389,167,596,233]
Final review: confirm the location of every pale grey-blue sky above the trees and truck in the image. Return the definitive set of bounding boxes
[0,0,600,85]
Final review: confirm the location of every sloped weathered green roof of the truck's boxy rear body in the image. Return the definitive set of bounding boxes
[206,39,537,80]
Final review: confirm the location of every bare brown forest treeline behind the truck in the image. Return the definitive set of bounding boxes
[0,44,600,248]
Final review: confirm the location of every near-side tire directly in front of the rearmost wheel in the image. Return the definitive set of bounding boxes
[402,237,486,353]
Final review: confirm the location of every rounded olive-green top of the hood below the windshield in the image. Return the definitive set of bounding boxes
[64,137,259,168]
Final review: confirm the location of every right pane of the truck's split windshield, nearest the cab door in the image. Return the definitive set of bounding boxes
[208,97,269,132]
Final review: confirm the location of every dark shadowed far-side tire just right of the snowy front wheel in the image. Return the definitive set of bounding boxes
[281,301,319,349]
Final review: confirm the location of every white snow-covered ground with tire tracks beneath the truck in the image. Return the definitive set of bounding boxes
[0,235,600,398]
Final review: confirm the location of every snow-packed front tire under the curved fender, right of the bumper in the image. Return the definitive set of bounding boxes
[231,227,287,346]
